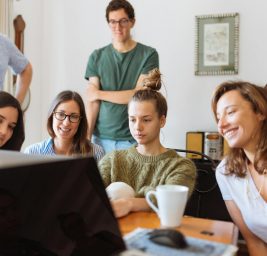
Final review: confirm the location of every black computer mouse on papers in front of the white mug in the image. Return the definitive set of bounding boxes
[149,229,187,249]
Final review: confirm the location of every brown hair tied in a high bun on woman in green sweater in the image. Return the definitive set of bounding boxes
[129,68,168,117]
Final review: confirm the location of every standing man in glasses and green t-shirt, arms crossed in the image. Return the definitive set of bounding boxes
[85,0,159,153]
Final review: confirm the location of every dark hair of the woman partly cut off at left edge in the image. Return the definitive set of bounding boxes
[0,91,25,151]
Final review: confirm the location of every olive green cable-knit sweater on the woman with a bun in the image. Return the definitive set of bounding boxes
[99,146,196,197]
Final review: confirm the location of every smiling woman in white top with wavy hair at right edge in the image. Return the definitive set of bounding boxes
[212,82,267,255]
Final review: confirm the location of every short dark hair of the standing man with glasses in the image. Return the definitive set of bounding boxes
[106,0,135,22]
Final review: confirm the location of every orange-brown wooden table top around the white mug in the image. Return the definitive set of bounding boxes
[118,212,238,245]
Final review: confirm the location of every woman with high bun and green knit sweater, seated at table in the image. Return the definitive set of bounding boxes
[99,69,196,217]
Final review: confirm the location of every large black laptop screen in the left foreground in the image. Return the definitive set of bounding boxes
[0,154,125,256]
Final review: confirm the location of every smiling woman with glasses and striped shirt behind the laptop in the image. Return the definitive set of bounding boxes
[25,91,104,160]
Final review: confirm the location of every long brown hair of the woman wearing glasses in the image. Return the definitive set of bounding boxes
[47,91,91,155]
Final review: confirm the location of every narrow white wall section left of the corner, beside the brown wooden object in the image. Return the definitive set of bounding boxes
[14,0,43,147]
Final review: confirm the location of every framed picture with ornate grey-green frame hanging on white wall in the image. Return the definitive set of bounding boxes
[195,13,239,76]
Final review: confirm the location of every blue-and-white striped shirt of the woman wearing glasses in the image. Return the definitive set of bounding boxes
[24,138,105,161]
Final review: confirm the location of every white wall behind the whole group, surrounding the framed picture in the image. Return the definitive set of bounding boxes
[15,0,267,148]
